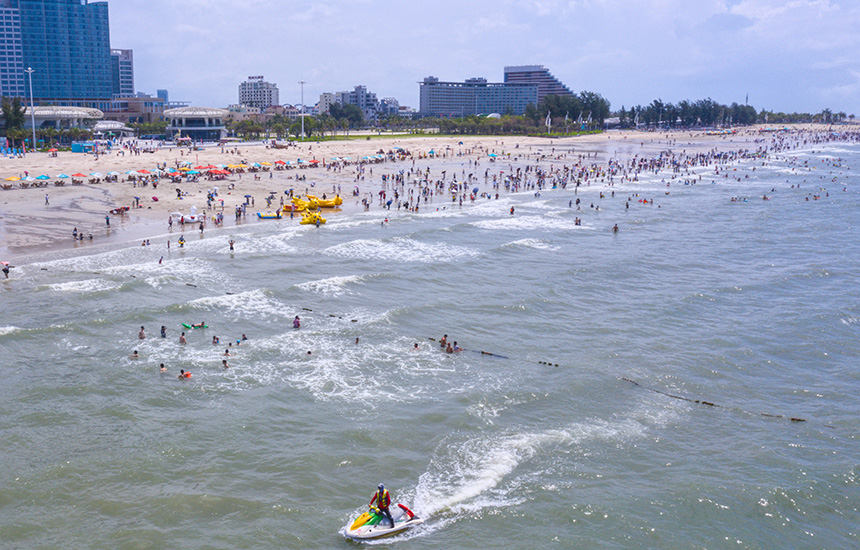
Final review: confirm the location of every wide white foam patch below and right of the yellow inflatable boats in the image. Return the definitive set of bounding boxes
[323,237,479,263]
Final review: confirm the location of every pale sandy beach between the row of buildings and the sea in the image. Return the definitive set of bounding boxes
[0,127,832,263]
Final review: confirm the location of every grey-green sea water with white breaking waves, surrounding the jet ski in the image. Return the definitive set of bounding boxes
[0,140,860,549]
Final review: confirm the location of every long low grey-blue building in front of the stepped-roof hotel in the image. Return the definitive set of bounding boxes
[419,76,538,117]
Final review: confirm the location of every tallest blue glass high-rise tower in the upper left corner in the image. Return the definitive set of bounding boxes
[0,0,113,100]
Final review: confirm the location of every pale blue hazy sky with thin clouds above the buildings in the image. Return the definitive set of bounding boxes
[109,0,860,115]
